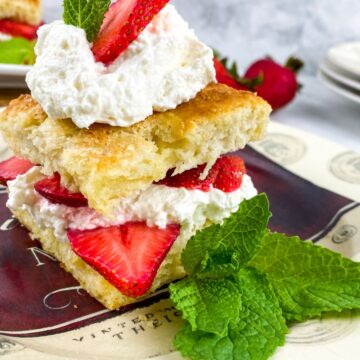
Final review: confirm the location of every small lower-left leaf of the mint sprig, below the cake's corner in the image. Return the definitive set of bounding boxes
[170,278,241,336]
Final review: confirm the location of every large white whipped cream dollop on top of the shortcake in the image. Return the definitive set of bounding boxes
[26,5,216,128]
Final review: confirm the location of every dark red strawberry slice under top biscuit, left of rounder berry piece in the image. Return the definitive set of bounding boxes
[157,165,217,192]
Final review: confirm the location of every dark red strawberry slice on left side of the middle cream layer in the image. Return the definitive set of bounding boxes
[34,173,88,207]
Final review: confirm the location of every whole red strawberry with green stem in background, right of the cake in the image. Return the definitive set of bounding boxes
[245,58,304,110]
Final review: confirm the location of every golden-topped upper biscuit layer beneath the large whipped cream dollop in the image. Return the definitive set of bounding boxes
[0,84,271,218]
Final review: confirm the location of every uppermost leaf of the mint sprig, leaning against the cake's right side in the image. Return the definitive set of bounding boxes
[182,194,271,274]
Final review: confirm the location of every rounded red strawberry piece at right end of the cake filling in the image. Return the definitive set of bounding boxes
[214,155,246,193]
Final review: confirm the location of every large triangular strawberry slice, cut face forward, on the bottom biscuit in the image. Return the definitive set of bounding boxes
[68,222,180,297]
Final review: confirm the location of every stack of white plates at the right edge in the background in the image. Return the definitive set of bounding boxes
[319,42,360,104]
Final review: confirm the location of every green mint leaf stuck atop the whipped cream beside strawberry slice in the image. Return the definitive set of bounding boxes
[63,0,111,42]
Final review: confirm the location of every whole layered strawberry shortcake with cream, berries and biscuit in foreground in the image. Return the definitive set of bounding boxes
[0,0,271,309]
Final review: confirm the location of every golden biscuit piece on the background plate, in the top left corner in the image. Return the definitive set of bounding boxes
[0,0,42,25]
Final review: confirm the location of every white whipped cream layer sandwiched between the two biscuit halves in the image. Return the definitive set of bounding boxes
[7,167,257,241]
